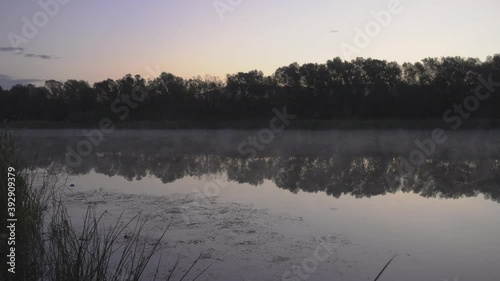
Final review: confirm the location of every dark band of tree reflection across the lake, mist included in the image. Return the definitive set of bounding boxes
[17,130,500,202]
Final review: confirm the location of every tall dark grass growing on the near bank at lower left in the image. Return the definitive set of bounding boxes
[0,130,208,281]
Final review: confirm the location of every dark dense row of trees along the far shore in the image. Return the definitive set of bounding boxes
[0,54,500,122]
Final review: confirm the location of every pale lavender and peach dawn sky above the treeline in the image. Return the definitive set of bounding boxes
[0,0,500,88]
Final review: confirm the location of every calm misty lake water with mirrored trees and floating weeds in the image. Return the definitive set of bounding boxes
[19,130,500,281]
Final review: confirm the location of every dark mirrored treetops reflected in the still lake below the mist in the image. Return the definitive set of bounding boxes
[18,138,500,202]
